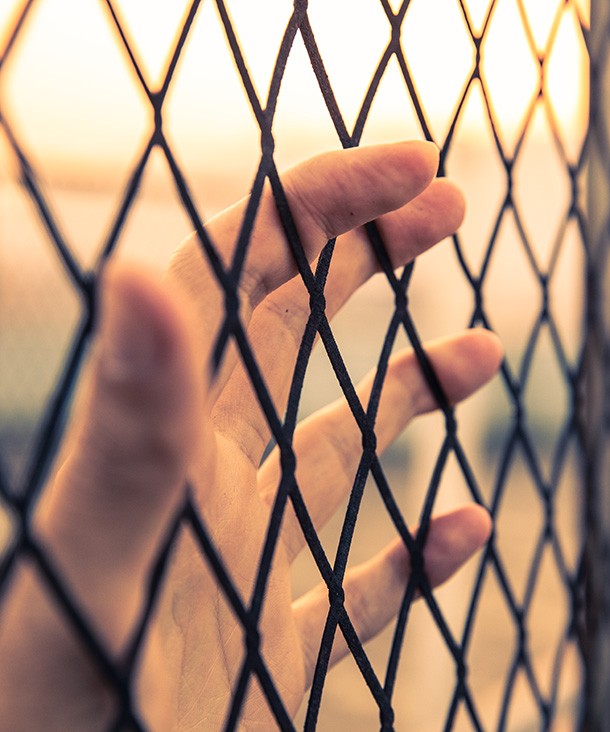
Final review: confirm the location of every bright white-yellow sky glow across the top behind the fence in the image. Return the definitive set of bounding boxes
[0,0,588,177]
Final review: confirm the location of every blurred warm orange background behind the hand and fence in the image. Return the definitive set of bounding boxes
[0,0,589,732]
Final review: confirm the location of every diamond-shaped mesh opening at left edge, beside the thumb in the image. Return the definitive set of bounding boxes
[0,177,82,488]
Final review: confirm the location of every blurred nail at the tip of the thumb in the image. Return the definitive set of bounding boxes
[101,282,166,381]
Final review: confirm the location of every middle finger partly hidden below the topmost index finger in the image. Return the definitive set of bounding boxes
[212,180,464,466]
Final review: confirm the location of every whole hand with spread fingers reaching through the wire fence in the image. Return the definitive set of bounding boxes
[0,142,501,732]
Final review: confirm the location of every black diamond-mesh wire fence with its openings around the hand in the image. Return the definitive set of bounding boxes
[0,0,610,729]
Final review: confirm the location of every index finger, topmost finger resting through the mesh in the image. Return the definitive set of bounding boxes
[169,141,438,386]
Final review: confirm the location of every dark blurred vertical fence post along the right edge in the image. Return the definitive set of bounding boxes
[583,0,610,732]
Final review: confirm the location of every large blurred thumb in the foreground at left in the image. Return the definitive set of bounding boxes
[38,270,203,650]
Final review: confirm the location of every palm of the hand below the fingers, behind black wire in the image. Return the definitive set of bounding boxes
[160,437,306,730]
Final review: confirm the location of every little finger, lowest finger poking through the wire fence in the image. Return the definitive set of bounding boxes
[293,505,491,685]
